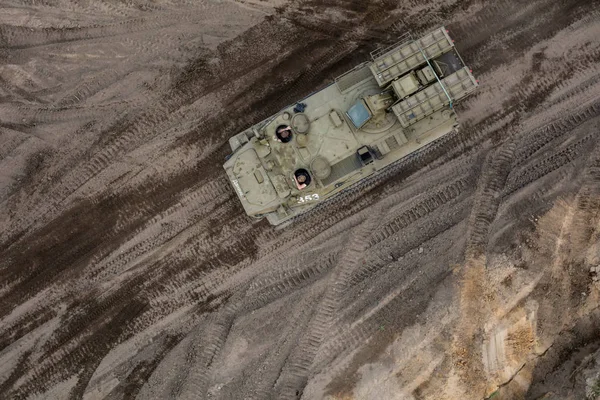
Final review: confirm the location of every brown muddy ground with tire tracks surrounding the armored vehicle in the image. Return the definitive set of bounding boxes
[0,0,600,400]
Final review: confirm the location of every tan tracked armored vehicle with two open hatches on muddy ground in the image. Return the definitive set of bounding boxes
[223,27,478,225]
